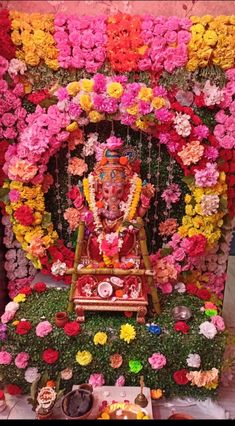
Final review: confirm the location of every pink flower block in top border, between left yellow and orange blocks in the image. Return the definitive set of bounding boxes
[54,13,107,73]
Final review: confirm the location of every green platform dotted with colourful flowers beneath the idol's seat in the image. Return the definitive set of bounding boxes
[0,283,226,400]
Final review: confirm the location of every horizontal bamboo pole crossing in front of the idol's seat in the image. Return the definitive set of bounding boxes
[66,267,155,275]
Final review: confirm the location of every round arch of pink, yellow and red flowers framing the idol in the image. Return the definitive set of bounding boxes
[4,74,231,302]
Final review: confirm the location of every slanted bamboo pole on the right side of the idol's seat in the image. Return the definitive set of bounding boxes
[137,217,161,315]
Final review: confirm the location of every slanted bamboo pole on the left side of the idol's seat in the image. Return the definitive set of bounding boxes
[67,222,85,312]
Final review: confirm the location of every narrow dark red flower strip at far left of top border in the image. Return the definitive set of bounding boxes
[0,9,16,61]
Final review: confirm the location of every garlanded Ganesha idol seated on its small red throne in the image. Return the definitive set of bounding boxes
[68,136,160,322]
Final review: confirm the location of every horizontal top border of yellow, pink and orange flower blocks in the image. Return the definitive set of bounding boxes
[3,11,235,74]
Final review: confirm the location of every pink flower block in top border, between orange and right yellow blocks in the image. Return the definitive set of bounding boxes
[139,15,192,73]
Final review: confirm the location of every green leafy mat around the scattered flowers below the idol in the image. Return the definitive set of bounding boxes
[0,289,225,399]
